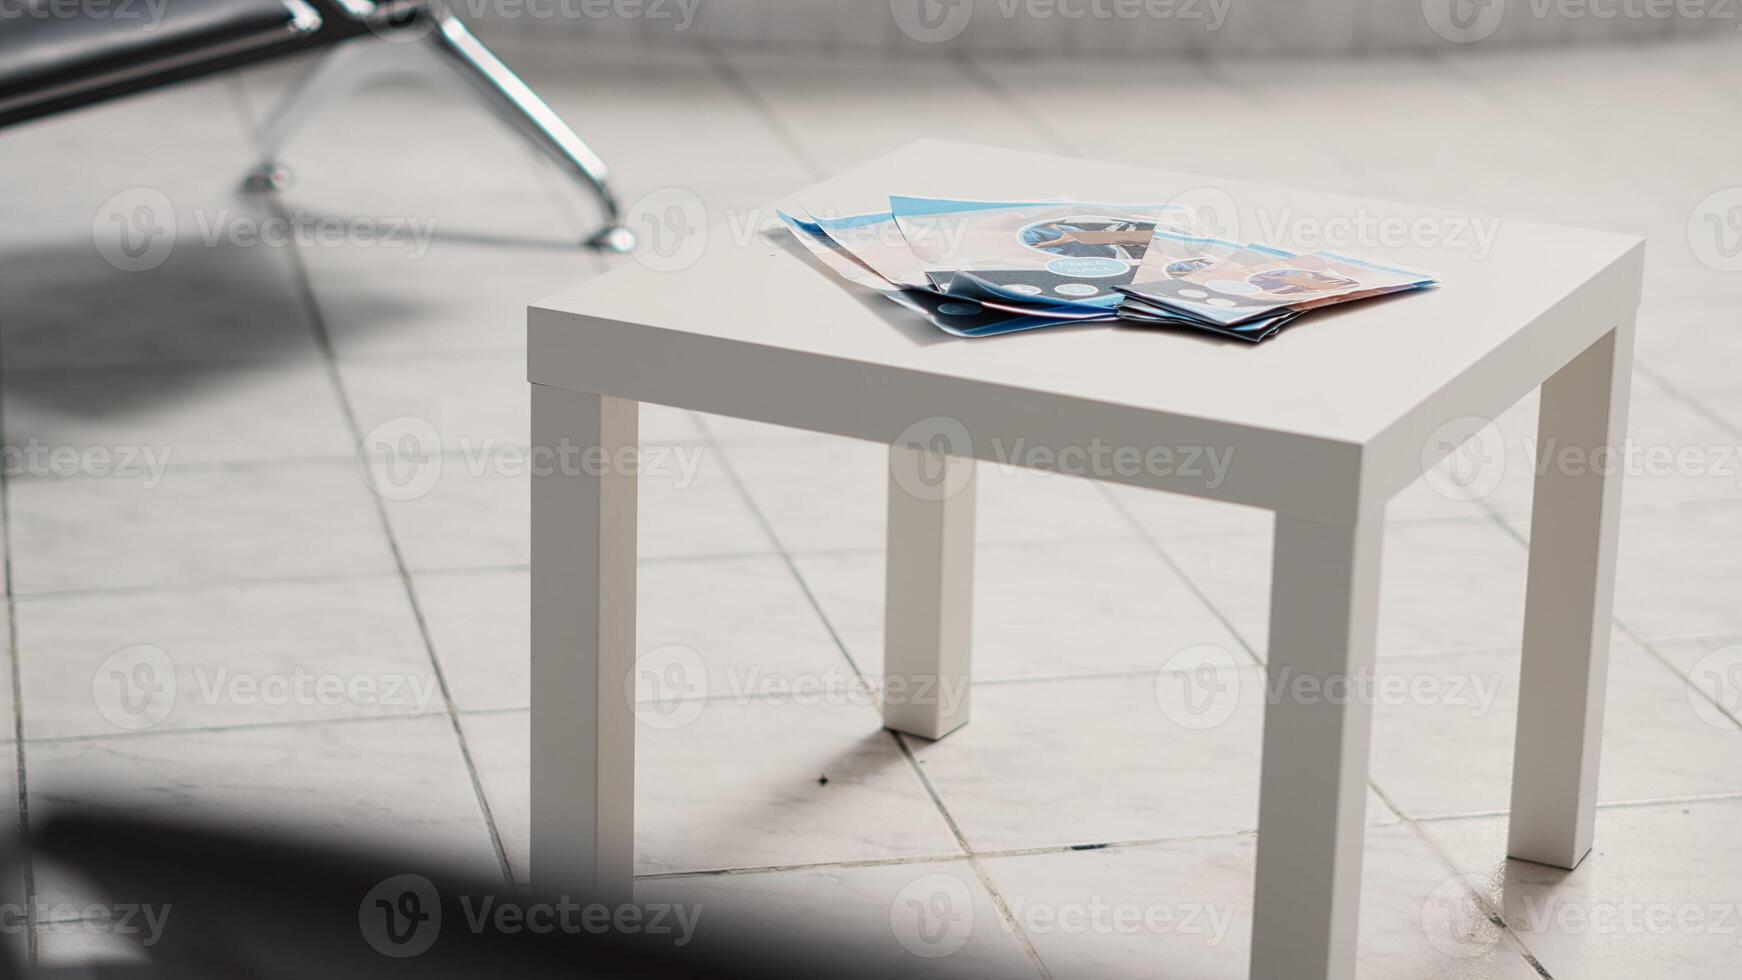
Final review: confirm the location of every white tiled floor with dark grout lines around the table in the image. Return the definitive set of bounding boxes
[0,26,1742,980]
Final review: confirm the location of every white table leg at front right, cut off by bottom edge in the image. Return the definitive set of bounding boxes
[1251,513,1383,980]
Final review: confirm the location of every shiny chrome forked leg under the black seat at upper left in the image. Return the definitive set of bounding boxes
[242,9,636,252]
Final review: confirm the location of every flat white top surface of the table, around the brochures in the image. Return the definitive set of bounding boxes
[530,141,1643,444]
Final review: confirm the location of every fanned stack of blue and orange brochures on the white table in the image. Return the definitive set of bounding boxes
[780,197,1437,343]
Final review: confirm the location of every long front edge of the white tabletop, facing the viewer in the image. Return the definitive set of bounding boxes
[526,305,1362,524]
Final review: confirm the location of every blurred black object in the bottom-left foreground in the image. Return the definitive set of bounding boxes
[3,815,873,980]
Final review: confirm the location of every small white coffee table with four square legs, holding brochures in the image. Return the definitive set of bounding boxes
[528,141,1644,980]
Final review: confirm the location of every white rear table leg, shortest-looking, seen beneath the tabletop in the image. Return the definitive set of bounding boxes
[883,446,976,738]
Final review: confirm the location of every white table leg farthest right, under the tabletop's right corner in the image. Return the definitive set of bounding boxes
[1507,319,1632,869]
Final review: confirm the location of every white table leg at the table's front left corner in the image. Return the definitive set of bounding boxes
[530,385,639,903]
